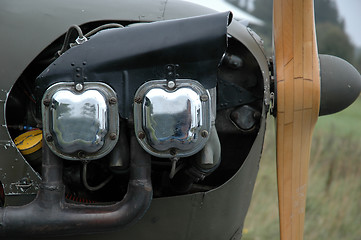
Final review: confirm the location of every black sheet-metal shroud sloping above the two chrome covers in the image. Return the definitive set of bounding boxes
[36,12,231,118]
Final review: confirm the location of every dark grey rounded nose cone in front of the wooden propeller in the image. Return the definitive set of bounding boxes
[319,54,361,116]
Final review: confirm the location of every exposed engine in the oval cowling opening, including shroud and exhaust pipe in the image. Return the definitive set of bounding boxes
[3,9,270,236]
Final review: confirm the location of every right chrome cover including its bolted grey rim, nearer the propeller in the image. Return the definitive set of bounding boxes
[134,79,211,157]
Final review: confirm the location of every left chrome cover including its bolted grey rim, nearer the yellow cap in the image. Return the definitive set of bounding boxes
[42,83,118,160]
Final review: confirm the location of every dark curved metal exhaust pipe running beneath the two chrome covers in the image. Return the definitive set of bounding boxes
[0,136,153,237]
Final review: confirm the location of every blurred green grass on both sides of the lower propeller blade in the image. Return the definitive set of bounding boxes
[242,98,361,240]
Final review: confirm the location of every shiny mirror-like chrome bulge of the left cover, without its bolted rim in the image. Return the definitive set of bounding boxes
[50,90,108,153]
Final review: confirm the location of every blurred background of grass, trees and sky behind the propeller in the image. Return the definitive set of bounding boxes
[184,0,361,240]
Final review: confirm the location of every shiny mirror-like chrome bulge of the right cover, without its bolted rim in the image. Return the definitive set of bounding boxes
[143,88,203,151]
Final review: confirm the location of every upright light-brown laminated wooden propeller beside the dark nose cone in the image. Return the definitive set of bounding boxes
[273,0,320,240]
